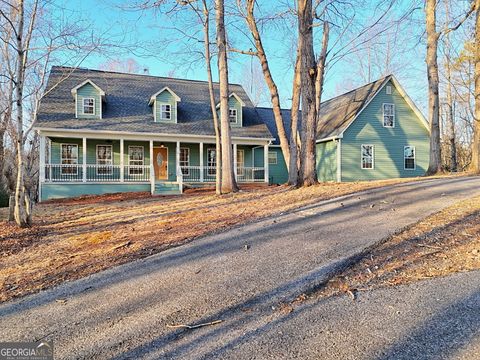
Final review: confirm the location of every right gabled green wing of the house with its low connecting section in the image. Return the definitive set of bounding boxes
[257,75,430,184]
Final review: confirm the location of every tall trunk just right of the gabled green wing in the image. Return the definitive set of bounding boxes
[425,0,442,175]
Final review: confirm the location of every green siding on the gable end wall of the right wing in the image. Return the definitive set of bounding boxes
[342,83,429,181]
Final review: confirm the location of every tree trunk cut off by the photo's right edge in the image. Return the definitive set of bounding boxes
[472,0,480,174]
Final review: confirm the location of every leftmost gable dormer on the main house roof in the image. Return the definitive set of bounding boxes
[71,79,105,119]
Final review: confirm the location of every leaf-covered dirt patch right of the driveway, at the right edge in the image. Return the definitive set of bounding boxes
[314,197,480,298]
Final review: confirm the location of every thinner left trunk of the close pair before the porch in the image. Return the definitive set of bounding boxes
[200,0,222,195]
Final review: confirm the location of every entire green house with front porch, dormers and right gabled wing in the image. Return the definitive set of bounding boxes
[35,67,429,200]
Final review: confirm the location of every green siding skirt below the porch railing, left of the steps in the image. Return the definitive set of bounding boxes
[41,183,150,201]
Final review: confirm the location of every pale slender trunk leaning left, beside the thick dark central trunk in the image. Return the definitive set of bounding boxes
[246,0,292,171]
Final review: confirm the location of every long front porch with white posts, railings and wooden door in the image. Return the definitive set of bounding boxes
[40,135,269,200]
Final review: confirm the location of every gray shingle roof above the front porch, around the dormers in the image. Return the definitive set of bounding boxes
[36,66,272,138]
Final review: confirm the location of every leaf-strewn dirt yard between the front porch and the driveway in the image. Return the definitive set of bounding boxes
[0,179,438,301]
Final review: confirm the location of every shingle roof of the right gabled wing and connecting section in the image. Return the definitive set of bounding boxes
[257,75,391,145]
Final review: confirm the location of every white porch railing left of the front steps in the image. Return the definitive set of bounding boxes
[45,164,150,182]
